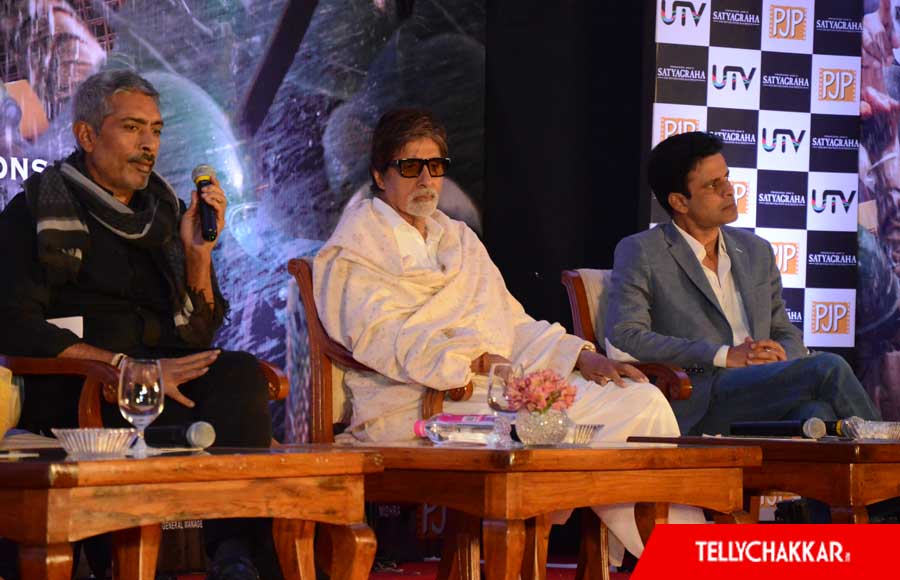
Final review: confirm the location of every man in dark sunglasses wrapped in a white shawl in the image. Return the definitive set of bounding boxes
[313,109,704,559]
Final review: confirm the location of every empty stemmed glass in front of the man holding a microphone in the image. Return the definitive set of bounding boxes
[119,358,165,457]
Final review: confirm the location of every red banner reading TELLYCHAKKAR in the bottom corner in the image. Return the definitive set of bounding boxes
[632,524,900,580]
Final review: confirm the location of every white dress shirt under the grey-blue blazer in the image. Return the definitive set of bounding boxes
[672,222,750,367]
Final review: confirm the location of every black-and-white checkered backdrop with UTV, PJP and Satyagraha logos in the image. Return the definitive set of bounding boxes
[651,0,863,350]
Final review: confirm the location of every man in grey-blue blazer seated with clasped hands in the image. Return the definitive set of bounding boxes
[606,132,880,434]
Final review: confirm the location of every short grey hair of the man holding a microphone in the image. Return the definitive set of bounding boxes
[72,70,159,133]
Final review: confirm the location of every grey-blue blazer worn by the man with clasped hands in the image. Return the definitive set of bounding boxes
[606,223,806,432]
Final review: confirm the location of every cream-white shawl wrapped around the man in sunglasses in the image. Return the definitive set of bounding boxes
[313,199,585,427]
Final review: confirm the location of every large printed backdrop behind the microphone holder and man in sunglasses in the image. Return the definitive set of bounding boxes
[0,0,486,442]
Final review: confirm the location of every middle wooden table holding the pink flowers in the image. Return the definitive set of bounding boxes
[358,443,760,580]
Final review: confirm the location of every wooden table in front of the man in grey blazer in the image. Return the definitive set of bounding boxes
[633,437,900,524]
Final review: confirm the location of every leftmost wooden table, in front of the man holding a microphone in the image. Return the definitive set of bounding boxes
[0,446,381,580]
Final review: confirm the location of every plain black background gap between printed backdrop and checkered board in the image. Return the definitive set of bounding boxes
[483,0,655,330]
